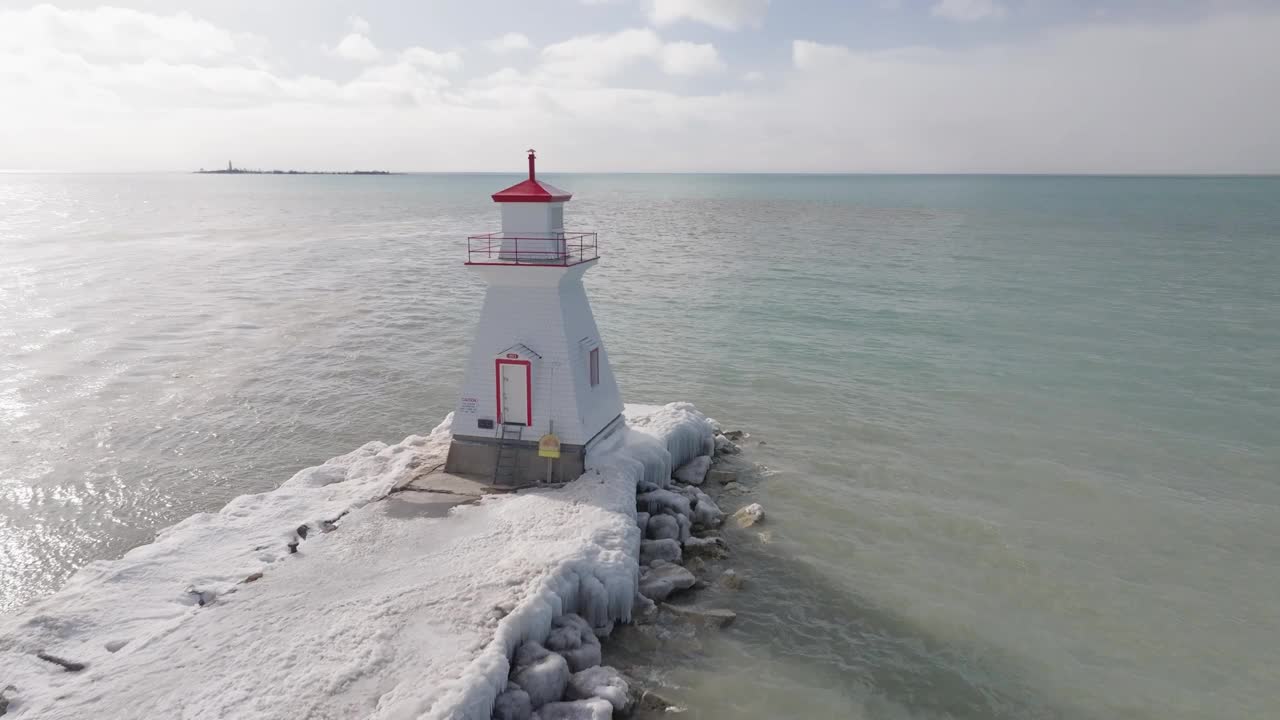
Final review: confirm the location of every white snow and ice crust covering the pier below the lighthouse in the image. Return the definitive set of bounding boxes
[0,404,713,720]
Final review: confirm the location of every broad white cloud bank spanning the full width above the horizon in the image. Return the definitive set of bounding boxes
[0,9,1280,173]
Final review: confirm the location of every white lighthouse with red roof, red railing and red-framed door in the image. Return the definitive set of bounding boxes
[444,150,622,486]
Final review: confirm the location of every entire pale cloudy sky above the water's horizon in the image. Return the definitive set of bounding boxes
[0,0,1280,173]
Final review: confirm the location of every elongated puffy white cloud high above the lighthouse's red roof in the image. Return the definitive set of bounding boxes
[538,28,724,83]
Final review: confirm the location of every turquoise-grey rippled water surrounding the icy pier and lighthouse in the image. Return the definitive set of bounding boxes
[0,170,1280,719]
